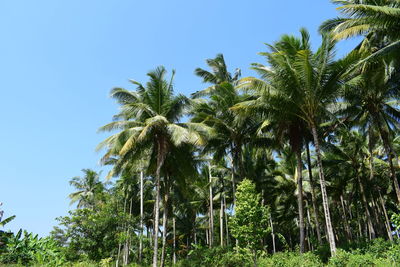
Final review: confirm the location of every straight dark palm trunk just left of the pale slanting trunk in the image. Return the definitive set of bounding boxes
[296,150,305,253]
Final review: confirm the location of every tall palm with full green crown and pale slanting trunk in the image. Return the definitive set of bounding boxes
[239,29,356,255]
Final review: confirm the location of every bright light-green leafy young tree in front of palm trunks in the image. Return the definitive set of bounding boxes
[230,179,270,251]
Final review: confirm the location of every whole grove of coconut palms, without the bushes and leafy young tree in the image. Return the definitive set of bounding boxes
[61,0,400,266]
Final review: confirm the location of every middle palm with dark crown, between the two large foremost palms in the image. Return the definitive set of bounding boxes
[191,54,256,209]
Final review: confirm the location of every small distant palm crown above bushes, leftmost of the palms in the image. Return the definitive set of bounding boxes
[69,169,104,209]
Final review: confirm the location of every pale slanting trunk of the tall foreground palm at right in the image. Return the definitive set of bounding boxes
[311,124,336,256]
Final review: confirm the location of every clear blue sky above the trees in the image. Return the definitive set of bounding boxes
[0,0,355,238]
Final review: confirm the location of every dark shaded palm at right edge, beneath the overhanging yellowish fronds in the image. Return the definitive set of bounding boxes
[339,42,400,203]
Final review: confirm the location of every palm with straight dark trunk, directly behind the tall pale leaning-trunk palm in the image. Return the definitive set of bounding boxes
[236,30,311,253]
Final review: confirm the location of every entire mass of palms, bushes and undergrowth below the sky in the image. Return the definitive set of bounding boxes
[0,0,400,267]
